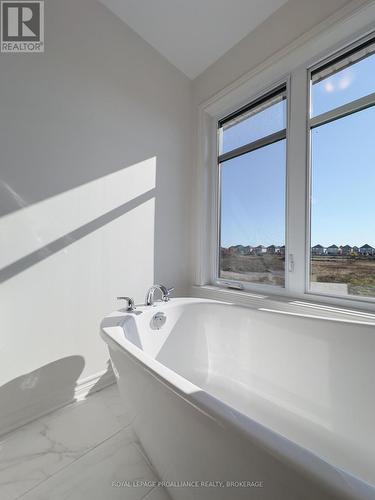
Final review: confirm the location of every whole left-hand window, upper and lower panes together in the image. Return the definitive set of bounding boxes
[218,85,287,287]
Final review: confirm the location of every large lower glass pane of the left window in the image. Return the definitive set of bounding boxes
[219,139,286,286]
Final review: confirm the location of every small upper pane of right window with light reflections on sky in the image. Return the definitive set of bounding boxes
[311,50,375,117]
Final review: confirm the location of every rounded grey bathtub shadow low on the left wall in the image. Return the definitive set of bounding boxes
[0,356,85,434]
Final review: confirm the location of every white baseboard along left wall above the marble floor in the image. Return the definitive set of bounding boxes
[0,370,116,437]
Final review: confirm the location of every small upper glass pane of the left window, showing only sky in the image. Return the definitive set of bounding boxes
[219,94,286,154]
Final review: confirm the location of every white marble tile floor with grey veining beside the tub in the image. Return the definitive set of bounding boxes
[0,385,169,500]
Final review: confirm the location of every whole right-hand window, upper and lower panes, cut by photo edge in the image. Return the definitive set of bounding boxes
[309,42,375,297]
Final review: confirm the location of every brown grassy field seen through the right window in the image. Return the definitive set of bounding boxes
[311,256,375,297]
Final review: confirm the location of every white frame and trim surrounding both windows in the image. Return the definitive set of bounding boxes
[193,3,375,310]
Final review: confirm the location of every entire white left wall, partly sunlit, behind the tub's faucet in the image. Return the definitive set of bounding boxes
[0,0,192,432]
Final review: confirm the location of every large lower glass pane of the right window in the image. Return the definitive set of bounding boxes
[310,107,375,297]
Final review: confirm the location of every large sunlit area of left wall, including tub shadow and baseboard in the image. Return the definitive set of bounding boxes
[0,157,156,434]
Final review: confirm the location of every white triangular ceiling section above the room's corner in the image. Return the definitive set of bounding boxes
[100,0,287,79]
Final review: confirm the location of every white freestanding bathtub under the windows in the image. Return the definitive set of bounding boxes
[101,298,375,500]
